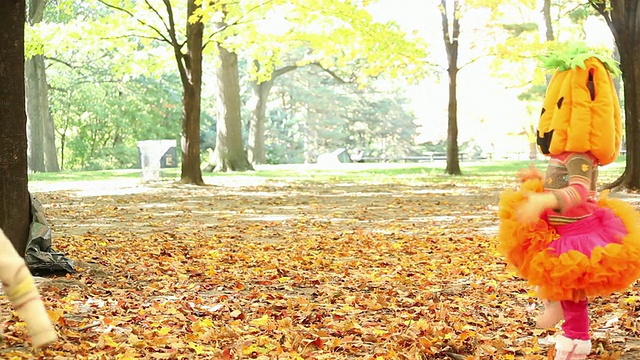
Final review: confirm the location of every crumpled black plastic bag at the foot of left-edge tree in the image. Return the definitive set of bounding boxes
[24,195,75,276]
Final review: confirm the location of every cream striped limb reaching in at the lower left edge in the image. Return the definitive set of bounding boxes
[0,230,58,347]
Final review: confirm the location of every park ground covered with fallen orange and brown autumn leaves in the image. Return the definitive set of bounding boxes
[0,173,640,359]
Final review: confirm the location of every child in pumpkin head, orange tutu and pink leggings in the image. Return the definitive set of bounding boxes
[499,47,640,359]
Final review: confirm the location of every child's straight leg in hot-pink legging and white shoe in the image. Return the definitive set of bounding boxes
[555,299,591,360]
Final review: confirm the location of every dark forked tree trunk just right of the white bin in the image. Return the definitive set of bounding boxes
[173,0,204,185]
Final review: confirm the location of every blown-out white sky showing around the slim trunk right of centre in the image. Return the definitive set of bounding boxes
[370,0,611,151]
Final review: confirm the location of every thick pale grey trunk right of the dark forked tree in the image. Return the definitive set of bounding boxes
[213,44,253,172]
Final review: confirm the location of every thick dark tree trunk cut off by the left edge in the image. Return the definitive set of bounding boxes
[0,0,31,256]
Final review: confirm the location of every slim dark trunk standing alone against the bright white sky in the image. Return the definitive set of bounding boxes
[440,0,462,175]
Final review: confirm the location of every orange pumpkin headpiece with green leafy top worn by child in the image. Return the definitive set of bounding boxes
[537,44,622,165]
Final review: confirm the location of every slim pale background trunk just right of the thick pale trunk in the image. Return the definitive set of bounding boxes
[247,78,273,164]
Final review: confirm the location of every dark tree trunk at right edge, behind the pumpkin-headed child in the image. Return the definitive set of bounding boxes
[590,0,640,190]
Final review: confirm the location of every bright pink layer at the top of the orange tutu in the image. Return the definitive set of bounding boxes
[549,208,627,257]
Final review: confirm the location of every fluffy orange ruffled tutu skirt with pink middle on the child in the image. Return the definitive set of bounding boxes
[498,180,640,301]
